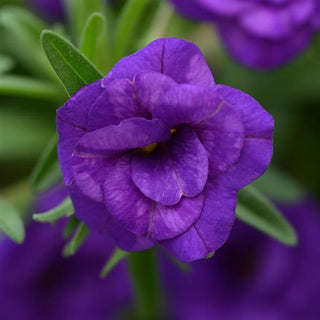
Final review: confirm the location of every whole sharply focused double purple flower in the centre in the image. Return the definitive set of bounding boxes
[57,38,273,261]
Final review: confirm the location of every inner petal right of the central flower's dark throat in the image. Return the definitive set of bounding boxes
[194,102,244,177]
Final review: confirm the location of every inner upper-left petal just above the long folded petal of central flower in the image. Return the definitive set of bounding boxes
[88,79,146,131]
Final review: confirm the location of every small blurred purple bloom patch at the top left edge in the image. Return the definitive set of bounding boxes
[26,0,65,22]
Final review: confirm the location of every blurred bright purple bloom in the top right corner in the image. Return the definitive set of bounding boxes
[171,0,320,69]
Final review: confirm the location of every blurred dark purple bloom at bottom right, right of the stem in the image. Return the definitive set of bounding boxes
[165,201,320,320]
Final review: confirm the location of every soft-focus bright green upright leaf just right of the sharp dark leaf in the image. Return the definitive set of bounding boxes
[80,13,109,72]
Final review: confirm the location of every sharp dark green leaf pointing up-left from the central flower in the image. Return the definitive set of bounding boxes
[41,30,103,96]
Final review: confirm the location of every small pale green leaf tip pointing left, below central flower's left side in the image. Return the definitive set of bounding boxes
[32,197,74,223]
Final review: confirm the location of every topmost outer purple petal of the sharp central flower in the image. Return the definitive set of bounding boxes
[104,38,214,86]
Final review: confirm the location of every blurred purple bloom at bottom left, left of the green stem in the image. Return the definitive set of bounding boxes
[0,186,131,320]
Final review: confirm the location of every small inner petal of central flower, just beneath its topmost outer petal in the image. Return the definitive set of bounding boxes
[133,71,177,112]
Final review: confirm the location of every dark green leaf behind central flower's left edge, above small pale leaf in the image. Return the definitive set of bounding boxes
[30,134,62,193]
